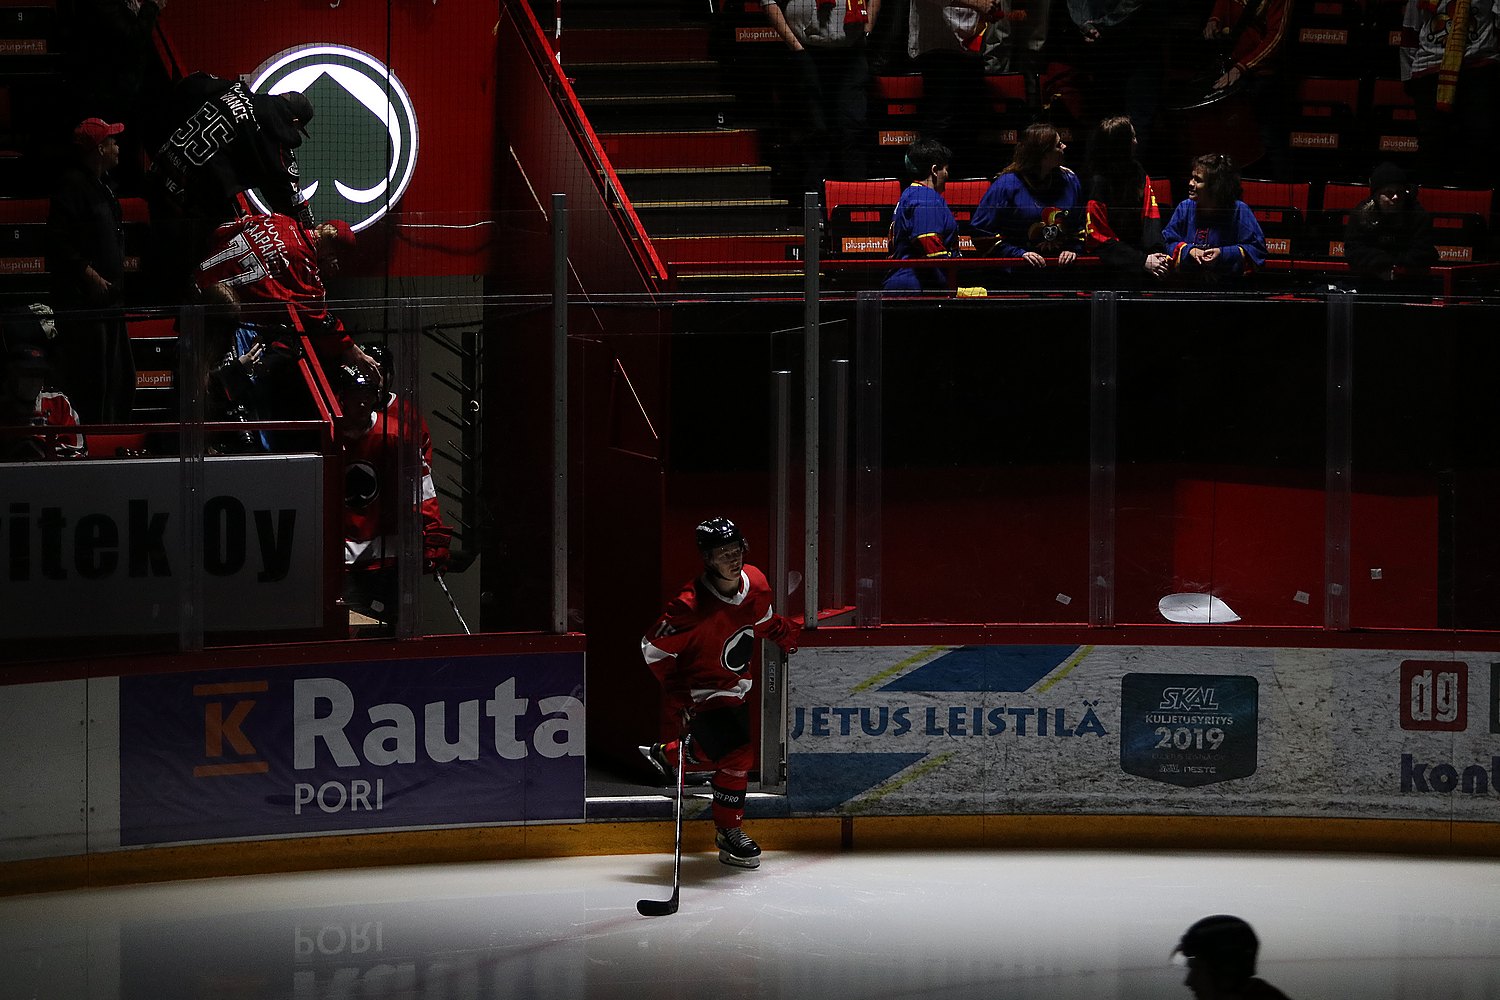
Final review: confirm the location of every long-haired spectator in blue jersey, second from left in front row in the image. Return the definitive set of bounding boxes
[969,124,1083,267]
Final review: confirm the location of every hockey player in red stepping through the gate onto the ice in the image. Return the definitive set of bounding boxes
[641,517,801,868]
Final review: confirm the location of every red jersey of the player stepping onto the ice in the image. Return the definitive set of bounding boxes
[641,565,800,711]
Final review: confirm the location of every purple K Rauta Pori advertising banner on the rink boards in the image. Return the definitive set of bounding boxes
[120,652,584,846]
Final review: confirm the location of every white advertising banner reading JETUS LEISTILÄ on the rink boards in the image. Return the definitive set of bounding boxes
[788,645,1500,822]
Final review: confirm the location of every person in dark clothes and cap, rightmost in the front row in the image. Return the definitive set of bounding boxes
[1344,163,1437,282]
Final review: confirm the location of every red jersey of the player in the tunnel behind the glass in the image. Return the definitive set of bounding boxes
[344,396,443,570]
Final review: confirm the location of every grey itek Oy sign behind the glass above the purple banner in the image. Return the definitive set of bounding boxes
[0,454,327,637]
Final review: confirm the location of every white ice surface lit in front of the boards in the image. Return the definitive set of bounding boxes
[0,852,1500,1000]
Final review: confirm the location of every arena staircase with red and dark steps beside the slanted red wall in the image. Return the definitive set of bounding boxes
[537,0,803,294]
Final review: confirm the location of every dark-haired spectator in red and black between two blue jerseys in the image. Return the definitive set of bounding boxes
[1085,117,1172,285]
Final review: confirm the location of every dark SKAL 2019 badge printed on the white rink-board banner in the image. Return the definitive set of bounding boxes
[1121,673,1260,789]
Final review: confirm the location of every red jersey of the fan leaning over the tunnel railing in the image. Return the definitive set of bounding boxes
[198,214,353,364]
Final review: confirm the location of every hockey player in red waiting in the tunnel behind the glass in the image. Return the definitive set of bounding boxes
[333,363,453,634]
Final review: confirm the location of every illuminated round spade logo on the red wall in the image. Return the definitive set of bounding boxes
[251,45,417,231]
